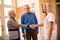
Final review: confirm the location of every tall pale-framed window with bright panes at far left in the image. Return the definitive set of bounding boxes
[0,0,14,40]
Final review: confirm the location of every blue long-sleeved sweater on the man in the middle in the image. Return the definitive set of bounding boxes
[21,13,38,33]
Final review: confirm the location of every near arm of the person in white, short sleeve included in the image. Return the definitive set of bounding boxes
[48,15,55,40]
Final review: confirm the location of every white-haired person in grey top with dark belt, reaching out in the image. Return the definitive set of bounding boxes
[7,10,27,40]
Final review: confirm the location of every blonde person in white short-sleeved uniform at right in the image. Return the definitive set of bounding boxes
[43,3,57,40]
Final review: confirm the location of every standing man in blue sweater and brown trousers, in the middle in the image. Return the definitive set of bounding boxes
[21,5,38,40]
